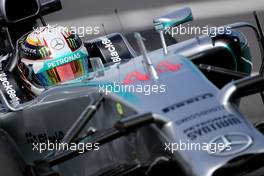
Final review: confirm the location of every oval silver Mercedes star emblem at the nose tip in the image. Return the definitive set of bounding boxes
[207,132,253,156]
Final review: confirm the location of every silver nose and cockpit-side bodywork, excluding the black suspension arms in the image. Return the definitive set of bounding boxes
[1,43,264,176]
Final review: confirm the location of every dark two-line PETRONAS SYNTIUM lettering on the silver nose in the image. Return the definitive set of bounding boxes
[183,114,242,140]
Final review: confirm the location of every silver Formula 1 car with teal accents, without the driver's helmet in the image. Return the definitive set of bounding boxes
[0,0,264,176]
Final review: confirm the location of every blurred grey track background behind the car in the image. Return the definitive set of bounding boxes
[45,0,264,122]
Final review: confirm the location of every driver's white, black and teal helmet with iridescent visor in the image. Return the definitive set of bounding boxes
[17,26,88,96]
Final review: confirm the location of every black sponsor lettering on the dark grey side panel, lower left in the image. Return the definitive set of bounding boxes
[25,131,64,144]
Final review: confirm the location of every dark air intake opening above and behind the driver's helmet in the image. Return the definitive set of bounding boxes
[0,0,41,24]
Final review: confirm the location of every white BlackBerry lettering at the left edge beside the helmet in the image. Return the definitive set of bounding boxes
[0,72,20,106]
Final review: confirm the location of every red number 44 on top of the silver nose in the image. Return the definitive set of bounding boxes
[123,61,182,84]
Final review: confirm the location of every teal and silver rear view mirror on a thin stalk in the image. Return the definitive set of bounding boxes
[153,7,193,31]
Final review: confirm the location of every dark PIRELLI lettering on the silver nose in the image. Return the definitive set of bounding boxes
[162,93,214,113]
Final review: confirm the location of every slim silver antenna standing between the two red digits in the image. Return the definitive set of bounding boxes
[134,32,159,80]
